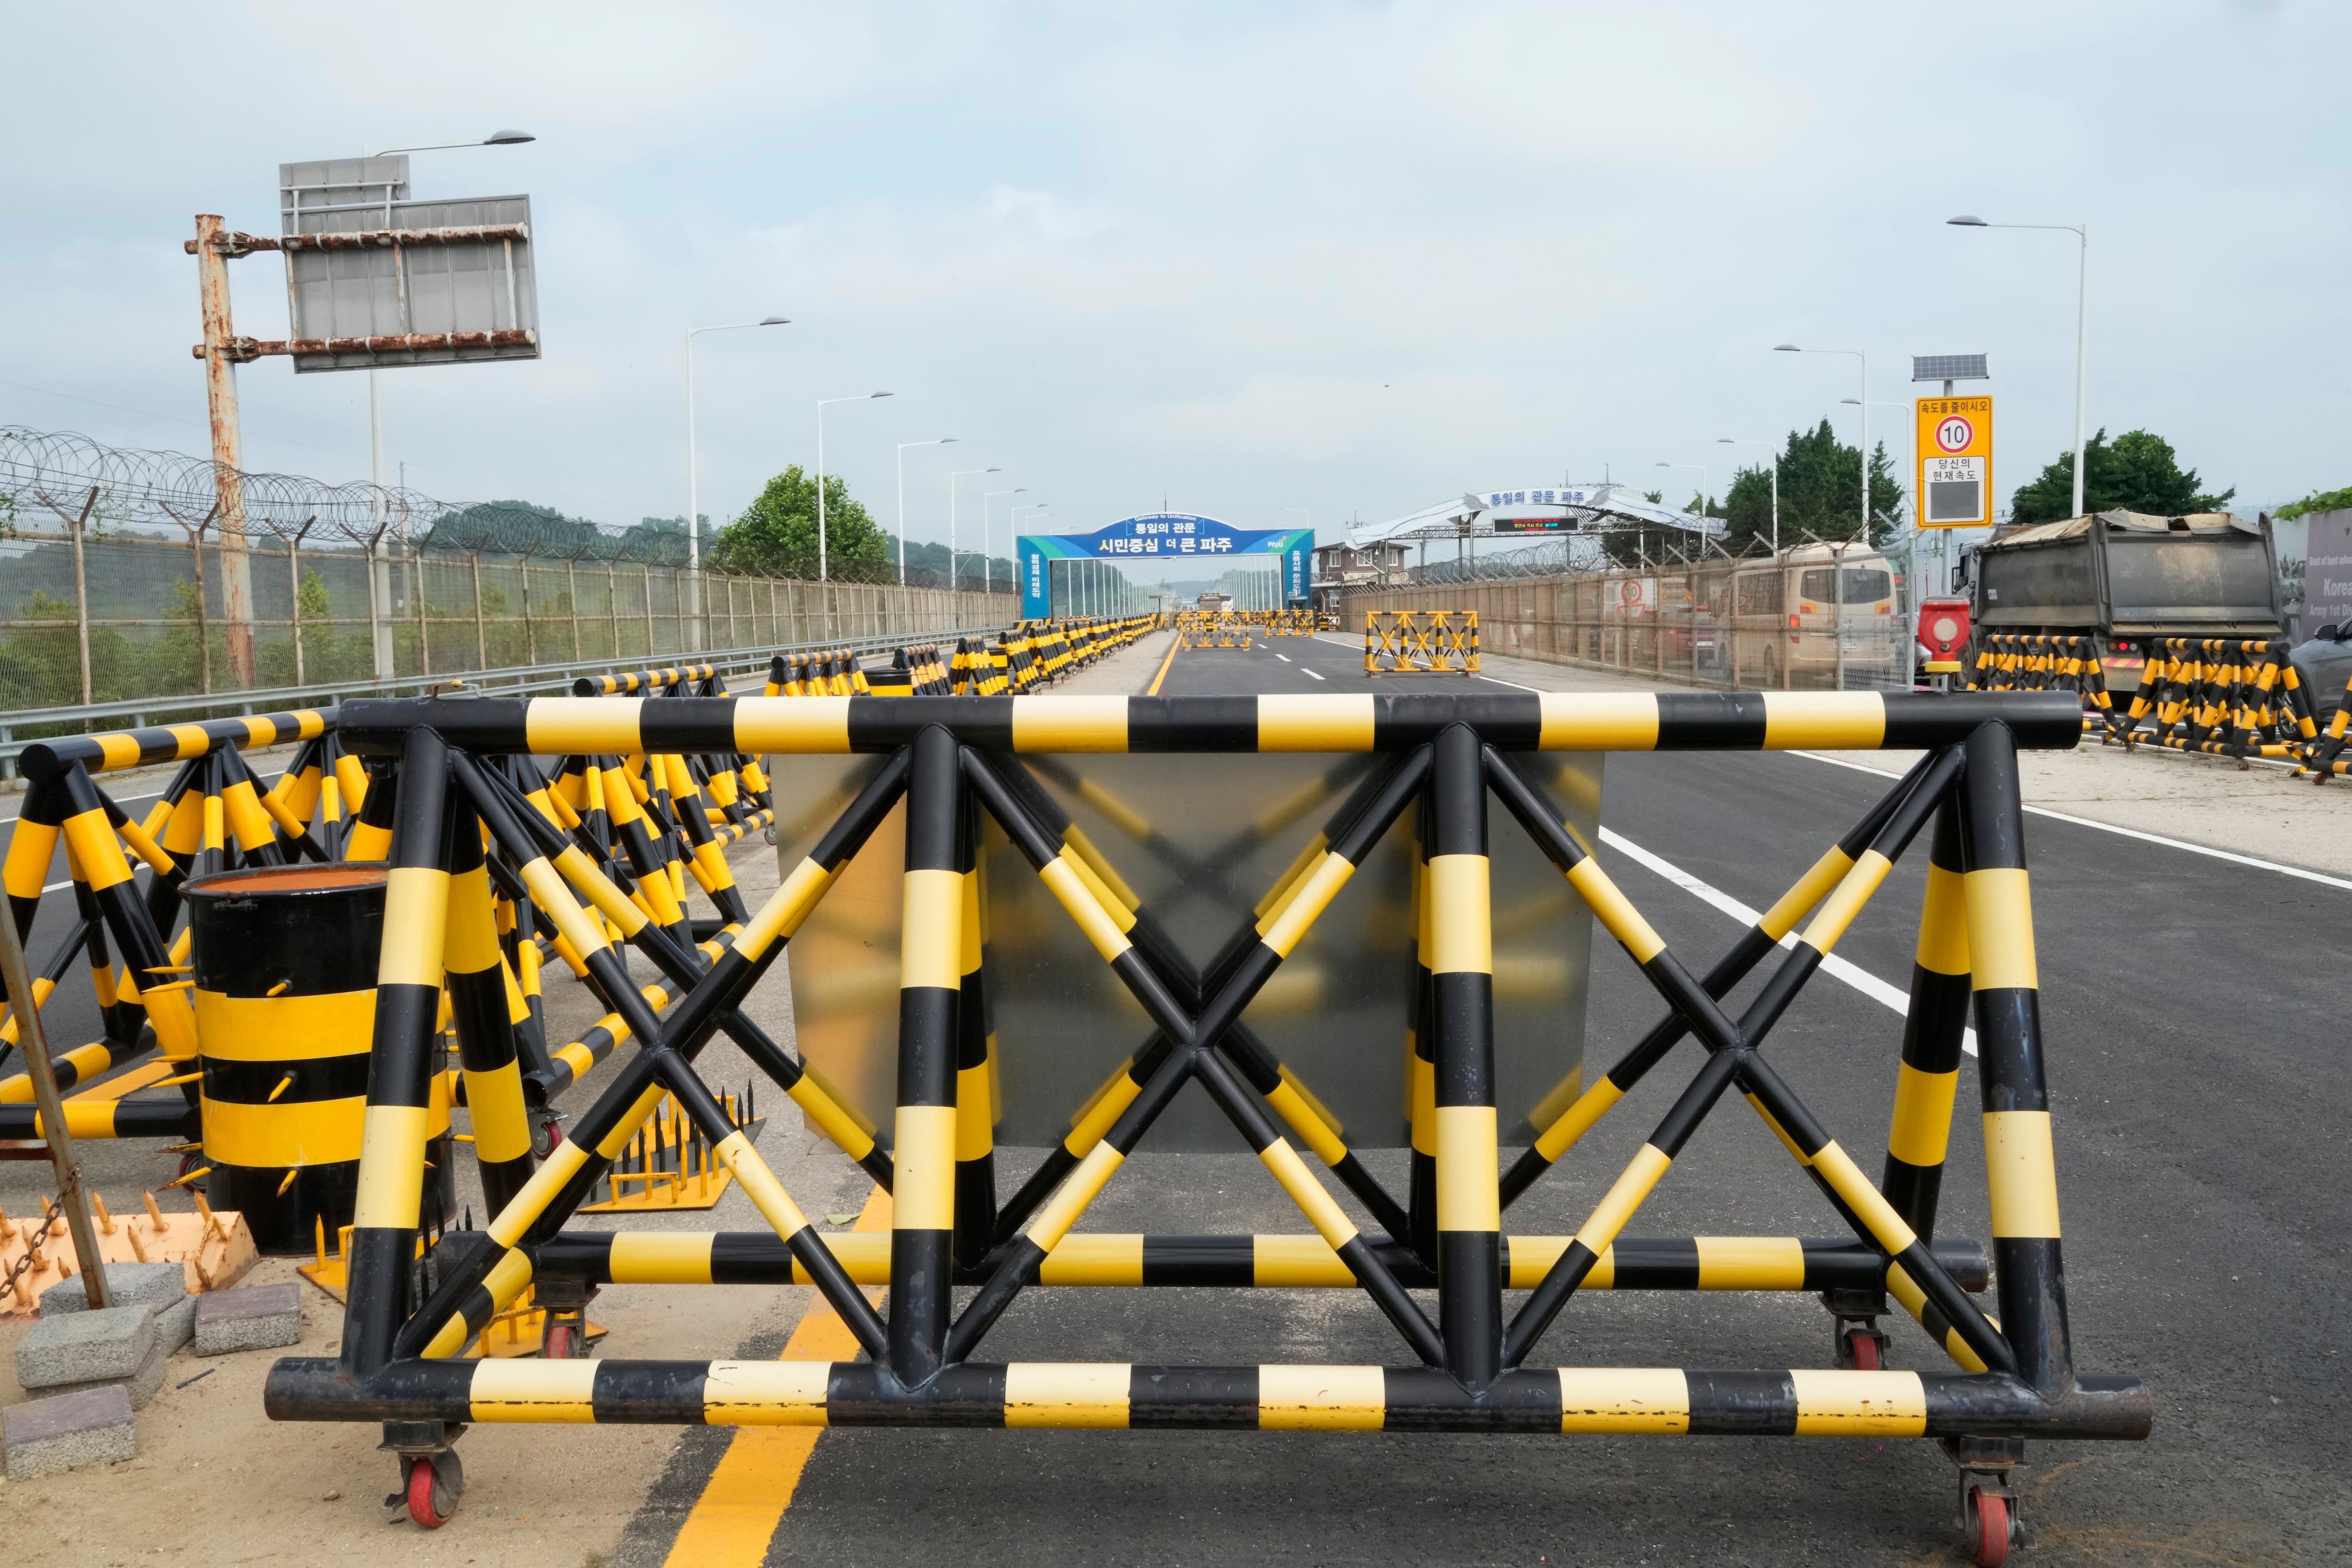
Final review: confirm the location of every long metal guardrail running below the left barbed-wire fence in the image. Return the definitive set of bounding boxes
[0,628,1007,783]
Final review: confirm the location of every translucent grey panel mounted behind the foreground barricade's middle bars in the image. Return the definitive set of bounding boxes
[767,752,1604,1150]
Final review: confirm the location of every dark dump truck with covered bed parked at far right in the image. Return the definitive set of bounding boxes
[1952,512,2279,696]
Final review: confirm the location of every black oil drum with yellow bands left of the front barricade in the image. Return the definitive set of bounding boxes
[181,863,456,1255]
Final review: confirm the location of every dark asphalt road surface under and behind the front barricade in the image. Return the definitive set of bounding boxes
[9,639,2352,1566]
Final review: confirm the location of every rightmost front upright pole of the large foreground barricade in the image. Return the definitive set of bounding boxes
[1959,724,2074,1396]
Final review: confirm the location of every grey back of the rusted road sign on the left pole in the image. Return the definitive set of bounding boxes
[278,155,539,372]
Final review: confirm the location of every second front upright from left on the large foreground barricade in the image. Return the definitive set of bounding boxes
[889,726,969,1387]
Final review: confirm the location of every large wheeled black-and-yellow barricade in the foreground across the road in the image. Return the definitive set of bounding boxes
[266,691,2152,1561]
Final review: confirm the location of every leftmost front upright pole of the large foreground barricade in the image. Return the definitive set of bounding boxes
[341,726,449,1377]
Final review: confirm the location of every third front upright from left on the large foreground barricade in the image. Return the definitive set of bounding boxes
[1428,724,1503,1389]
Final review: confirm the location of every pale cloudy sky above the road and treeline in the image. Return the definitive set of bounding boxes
[0,0,2352,581]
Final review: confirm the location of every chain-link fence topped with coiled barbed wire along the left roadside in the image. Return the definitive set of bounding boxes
[0,428,1016,712]
